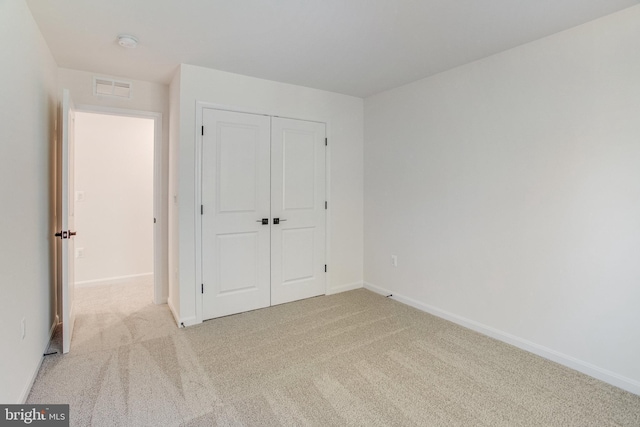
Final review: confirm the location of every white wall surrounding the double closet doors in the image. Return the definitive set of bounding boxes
[175,64,363,324]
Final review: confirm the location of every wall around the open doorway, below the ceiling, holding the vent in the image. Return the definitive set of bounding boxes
[58,68,169,302]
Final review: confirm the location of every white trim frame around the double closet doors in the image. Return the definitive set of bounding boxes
[193,101,331,323]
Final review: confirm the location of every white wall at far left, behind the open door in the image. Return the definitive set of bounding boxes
[0,0,58,403]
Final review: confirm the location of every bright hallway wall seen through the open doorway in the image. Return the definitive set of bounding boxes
[75,112,155,285]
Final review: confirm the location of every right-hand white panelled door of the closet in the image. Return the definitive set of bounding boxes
[271,117,326,305]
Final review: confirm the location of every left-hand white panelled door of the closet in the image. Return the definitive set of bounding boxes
[202,109,271,319]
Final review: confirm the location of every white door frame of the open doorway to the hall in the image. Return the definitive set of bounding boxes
[76,105,167,304]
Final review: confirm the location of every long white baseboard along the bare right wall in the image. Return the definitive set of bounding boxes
[364,282,640,395]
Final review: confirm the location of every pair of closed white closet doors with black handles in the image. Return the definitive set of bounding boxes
[201,108,326,319]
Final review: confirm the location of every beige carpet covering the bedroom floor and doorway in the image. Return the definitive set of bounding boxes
[28,282,640,426]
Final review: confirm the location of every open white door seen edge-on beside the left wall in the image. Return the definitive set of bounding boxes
[56,89,76,353]
